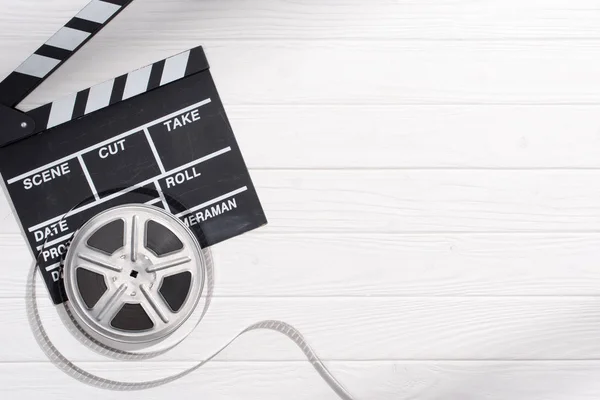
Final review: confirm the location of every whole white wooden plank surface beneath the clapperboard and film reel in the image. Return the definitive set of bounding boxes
[0,0,600,400]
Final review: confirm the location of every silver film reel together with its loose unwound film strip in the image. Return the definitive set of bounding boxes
[26,204,354,400]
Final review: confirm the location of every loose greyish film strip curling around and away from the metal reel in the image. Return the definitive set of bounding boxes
[26,189,354,400]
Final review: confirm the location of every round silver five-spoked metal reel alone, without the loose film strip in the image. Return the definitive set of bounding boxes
[64,204,206,351]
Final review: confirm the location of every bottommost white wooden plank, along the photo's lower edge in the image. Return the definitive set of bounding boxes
[0,361,600,400]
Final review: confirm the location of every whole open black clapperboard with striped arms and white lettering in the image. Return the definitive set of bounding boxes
[0,0,267,304]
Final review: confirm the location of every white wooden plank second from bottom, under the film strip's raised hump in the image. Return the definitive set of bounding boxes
[0,296,600,362]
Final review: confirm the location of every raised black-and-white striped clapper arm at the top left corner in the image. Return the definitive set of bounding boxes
[0,0,133,107]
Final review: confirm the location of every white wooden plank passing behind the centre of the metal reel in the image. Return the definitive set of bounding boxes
[5,233,600,298]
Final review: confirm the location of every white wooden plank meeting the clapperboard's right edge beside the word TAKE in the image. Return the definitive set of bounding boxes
[228,105,600,169]
